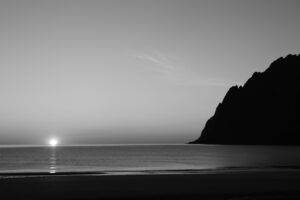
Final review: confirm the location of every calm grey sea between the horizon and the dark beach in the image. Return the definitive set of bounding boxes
[0,145,300,174]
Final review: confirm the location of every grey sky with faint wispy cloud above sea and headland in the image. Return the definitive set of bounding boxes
[0,0,300,145]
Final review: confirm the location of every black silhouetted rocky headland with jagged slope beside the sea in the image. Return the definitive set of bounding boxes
[191,55,300,145]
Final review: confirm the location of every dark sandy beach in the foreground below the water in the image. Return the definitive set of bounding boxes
[0,170,300,200]
